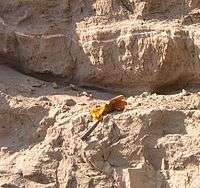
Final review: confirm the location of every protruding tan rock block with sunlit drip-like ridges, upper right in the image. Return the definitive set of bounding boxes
[78,26,200,89]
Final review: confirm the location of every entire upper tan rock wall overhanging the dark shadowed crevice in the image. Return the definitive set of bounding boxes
[0,0,200,91]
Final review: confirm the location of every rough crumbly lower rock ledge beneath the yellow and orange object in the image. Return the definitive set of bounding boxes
[0,65,200,188]
